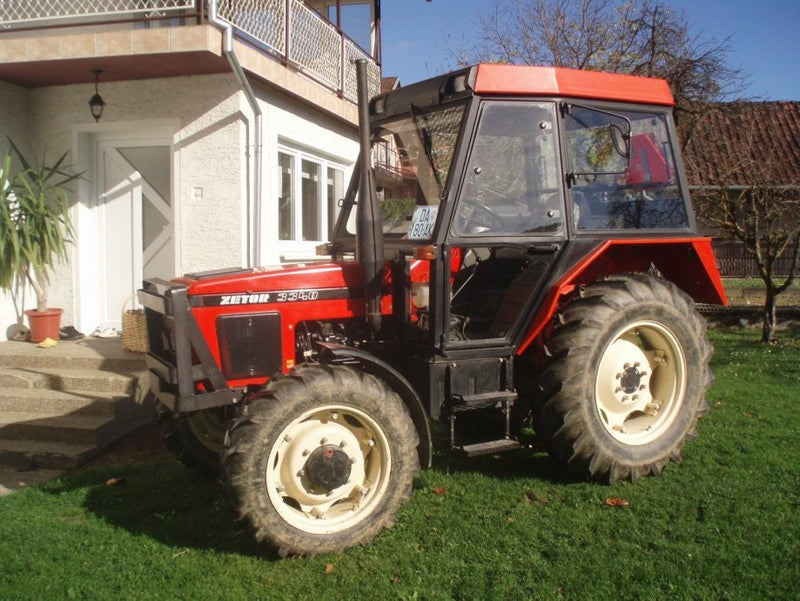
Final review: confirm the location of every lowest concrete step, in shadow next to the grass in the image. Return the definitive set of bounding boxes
[0,439,100,477]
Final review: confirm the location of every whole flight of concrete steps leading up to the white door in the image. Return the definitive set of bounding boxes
[0,338,154,470]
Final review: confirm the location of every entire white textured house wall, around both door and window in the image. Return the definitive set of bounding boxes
[0,74,358,336]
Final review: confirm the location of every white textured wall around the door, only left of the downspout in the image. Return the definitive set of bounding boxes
[0,75,246,329]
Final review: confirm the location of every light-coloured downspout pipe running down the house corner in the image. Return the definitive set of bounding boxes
[208,0,264,267]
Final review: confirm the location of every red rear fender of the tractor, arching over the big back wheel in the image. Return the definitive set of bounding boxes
[517,238,728,355]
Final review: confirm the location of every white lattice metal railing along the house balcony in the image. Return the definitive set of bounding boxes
[0,0,381,102]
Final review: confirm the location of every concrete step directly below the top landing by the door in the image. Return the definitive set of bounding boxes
[0,367,141,396]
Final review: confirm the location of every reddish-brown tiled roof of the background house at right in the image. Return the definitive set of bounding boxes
[680,101,800,186]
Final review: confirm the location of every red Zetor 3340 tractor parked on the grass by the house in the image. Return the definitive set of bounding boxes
[139,64,726,555]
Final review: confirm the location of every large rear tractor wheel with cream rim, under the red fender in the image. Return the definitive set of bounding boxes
[534,274,713,482]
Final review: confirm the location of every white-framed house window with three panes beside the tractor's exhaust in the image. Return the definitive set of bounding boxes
[278,148,344,246]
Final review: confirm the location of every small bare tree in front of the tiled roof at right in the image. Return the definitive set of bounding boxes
[684,102,800,342]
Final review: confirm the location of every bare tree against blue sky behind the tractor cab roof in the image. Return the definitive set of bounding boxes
[450,0,744,113]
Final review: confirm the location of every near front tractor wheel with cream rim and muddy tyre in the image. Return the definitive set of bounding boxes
[223,366,419,556]
